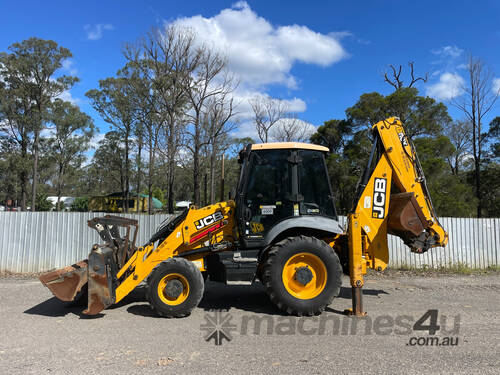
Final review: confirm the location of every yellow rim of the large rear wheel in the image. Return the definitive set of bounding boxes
[282,253,327,299]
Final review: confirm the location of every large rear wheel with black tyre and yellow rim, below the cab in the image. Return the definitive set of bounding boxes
[262,236,342,316]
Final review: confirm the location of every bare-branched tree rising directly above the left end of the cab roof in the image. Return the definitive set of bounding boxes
[250,96,289,143]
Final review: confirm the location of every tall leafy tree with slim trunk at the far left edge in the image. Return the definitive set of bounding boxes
[0,38,78,211]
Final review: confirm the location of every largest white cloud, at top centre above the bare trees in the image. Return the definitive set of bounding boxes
[171,1,348,88]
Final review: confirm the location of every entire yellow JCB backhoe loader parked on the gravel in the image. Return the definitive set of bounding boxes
[40,117,448,318]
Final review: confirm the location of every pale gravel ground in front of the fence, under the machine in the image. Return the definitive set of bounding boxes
[0,274,500,374]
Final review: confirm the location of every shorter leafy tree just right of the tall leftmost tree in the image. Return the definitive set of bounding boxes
[48,99,94,210]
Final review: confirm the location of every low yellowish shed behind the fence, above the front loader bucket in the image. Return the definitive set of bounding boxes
[89,192,163,212]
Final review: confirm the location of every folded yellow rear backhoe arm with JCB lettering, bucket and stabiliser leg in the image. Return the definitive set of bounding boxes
[347,117,448,315]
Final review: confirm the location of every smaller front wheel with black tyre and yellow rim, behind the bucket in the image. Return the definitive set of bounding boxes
[146,258,205,318]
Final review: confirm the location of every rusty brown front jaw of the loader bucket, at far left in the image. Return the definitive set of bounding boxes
[38,259,88,301]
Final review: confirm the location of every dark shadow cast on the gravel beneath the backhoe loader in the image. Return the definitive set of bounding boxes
[24,281,388,319]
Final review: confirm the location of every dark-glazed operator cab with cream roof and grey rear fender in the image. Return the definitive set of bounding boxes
[235,142,342,248]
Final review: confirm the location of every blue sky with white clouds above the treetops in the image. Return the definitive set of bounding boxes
[0,0,500,140]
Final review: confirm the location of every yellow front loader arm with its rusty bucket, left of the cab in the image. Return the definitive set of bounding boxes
[39,201,235,315]
